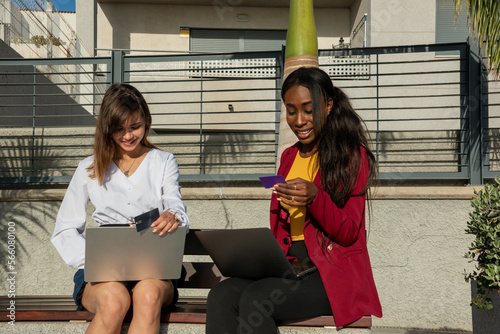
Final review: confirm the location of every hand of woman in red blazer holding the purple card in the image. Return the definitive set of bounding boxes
[272,177,318,206]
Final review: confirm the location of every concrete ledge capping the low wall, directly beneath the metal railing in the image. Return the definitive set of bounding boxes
[0,186,483,202]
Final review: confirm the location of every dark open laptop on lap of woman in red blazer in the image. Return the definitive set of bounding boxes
[195,228,317,279]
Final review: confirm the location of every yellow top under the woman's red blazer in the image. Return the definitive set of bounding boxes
[280,152,318,241]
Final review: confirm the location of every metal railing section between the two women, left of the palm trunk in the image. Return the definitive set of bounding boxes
[121,52,282,179]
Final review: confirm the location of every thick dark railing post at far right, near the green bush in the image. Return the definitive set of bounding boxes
[464,41,483,185]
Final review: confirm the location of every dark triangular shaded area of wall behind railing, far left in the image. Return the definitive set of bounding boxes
[0,40,95,127]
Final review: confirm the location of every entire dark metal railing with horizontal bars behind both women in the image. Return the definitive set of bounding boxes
[0,43,500,184]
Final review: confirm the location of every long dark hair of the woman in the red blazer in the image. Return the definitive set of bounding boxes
[281,67,376,208]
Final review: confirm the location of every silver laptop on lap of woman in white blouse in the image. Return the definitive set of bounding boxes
[85,226,186,282]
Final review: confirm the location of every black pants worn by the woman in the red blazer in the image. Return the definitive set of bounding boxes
[206,242,332,334]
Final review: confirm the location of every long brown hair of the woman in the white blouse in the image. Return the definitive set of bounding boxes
[87,84,155,185]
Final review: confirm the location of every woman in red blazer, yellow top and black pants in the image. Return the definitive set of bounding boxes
[207,68,382,334]
